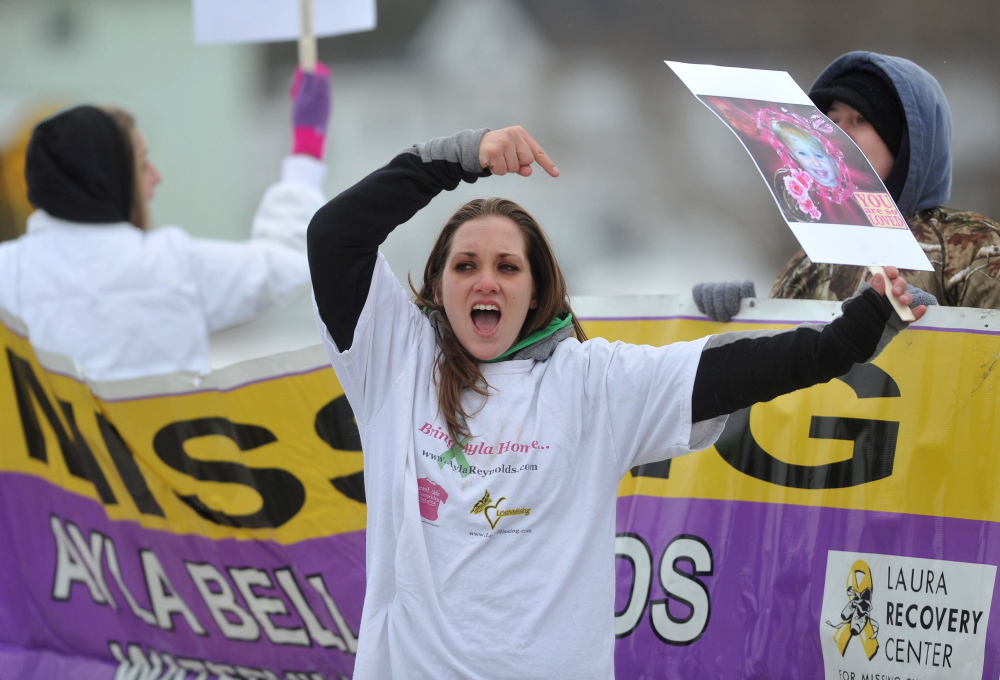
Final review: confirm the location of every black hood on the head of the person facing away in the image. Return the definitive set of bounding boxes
[24,106,135,223]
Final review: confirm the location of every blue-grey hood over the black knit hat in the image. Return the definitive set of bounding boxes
[810,52,951,215]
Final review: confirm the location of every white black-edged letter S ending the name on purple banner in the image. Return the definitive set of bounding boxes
[649,535,713,645]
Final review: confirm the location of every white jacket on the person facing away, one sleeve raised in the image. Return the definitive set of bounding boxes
[0,156,325,380]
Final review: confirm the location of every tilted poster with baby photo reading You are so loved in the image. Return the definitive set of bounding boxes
[666,61,931,270]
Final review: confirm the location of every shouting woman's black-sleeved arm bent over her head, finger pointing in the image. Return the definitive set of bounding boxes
[307,127,559,351]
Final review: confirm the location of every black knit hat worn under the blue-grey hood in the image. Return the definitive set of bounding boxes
[809,71,906,158]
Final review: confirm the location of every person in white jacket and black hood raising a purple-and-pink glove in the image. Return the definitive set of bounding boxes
[0,69,330,381]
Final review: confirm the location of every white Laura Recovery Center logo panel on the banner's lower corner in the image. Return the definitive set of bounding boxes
[820,550,996,680]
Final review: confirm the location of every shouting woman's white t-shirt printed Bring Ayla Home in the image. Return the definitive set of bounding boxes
[319,255,725,680]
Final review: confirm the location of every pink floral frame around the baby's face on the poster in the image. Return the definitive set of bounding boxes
[754,106,857,221]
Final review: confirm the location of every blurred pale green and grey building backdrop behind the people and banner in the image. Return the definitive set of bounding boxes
[0,0,1000,365]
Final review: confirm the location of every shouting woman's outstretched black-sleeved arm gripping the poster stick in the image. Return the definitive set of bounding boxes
[691,267,926,423]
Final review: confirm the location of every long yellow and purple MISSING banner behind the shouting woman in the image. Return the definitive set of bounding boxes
[0,298,1000,680]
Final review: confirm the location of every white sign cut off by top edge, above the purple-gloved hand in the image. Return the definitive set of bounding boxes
[192,0,375,43]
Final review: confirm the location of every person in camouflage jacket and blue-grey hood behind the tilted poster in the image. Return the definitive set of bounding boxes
[770,52,1000,309]
